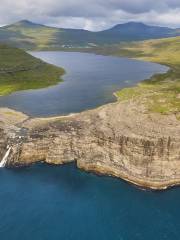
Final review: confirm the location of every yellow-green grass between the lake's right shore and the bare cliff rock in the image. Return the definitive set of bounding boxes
[116,71,180,114]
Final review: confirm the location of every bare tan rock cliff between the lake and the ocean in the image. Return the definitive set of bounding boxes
[0,101,180,189]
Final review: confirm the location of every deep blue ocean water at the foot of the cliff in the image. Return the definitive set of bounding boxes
[0,164,180,240]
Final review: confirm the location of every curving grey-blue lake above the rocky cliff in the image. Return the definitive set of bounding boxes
[0,52,168,116]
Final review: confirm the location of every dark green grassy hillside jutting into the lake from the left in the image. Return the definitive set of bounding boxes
[0,44,64,95]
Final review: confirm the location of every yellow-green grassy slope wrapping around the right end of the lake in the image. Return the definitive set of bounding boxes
[109,37,180,118]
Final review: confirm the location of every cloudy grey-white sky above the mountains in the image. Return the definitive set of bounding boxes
[0,0,180,31]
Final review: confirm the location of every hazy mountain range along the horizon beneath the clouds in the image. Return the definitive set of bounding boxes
[0,20,180,50]
